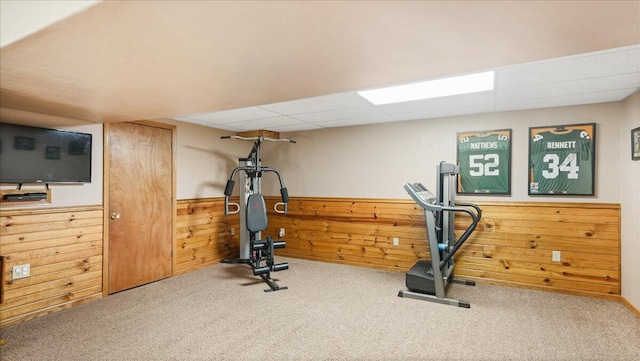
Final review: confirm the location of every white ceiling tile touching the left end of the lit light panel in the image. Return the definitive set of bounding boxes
[260,92,371,115]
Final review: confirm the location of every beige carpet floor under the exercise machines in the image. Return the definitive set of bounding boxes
[0,257,640,361]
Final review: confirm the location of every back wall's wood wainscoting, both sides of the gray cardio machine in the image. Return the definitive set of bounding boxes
[265,197,620,299]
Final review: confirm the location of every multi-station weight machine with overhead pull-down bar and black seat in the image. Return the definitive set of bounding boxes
[221,135,295,292]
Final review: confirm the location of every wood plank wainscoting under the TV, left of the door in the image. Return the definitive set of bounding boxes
[0,206,103,327]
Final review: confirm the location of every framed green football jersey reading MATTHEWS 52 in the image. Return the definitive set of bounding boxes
[457,129,511,194]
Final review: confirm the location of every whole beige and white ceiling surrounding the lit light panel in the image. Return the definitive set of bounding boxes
[0,1,640,132]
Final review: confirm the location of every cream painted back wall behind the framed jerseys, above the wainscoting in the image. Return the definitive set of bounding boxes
[274,102,621,203]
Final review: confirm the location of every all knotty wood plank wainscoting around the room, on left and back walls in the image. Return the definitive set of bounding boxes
[0,197,620,327]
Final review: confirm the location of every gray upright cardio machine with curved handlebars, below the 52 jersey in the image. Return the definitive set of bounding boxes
[398,162,482,308]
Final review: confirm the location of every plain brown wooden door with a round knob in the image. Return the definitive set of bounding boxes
[107,123,174,293]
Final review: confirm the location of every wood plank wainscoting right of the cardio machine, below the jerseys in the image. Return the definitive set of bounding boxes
[456,203,621,299]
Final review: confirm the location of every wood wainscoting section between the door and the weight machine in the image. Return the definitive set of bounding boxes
[174,198,240,275]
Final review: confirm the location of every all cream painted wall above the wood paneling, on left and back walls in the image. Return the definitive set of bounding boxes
[3,102,625,206]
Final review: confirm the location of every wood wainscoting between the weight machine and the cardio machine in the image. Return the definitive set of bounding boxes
[265,198,429,272]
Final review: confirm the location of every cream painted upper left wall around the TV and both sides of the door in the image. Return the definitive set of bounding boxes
[0,114,279,209]
